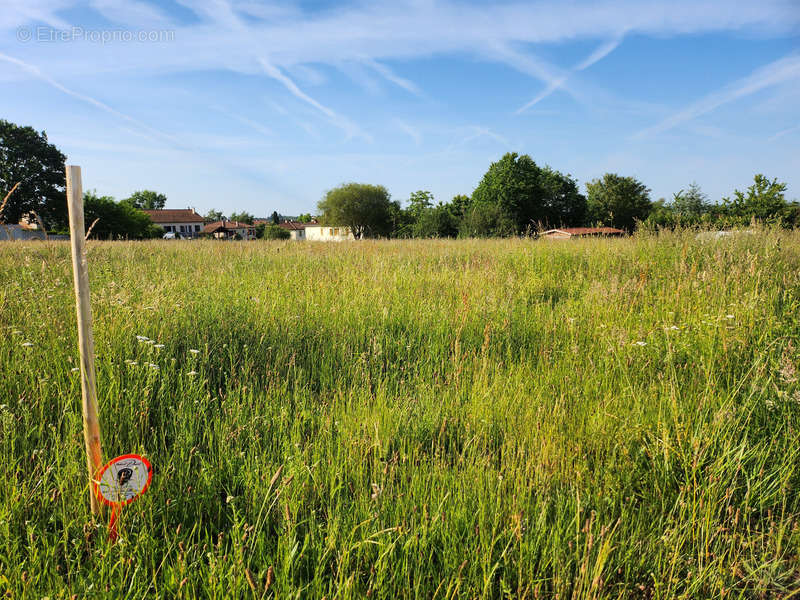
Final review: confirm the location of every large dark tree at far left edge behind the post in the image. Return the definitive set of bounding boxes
[0,119,67,228]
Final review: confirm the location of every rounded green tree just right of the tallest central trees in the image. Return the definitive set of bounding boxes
[586,173,653,231]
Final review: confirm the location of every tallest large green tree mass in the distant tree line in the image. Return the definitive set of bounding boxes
[467,152,586,234]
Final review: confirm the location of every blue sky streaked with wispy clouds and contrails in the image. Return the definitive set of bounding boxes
[0,0,800,216]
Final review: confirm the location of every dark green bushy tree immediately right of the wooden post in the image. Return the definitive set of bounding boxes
[83,190,164,239]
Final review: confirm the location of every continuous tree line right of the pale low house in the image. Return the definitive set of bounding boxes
[318,153,800,238]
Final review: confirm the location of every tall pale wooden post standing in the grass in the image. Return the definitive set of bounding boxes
[67,166,103,515]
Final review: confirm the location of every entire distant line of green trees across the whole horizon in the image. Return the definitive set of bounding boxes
[0,120,800,239]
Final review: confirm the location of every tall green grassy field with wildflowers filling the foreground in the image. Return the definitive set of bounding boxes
[0,231,800,600]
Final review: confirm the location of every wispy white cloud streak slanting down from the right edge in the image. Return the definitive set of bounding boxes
[633,53,800,139]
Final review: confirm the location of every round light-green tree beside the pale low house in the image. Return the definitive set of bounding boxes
[317,183,399,240]
